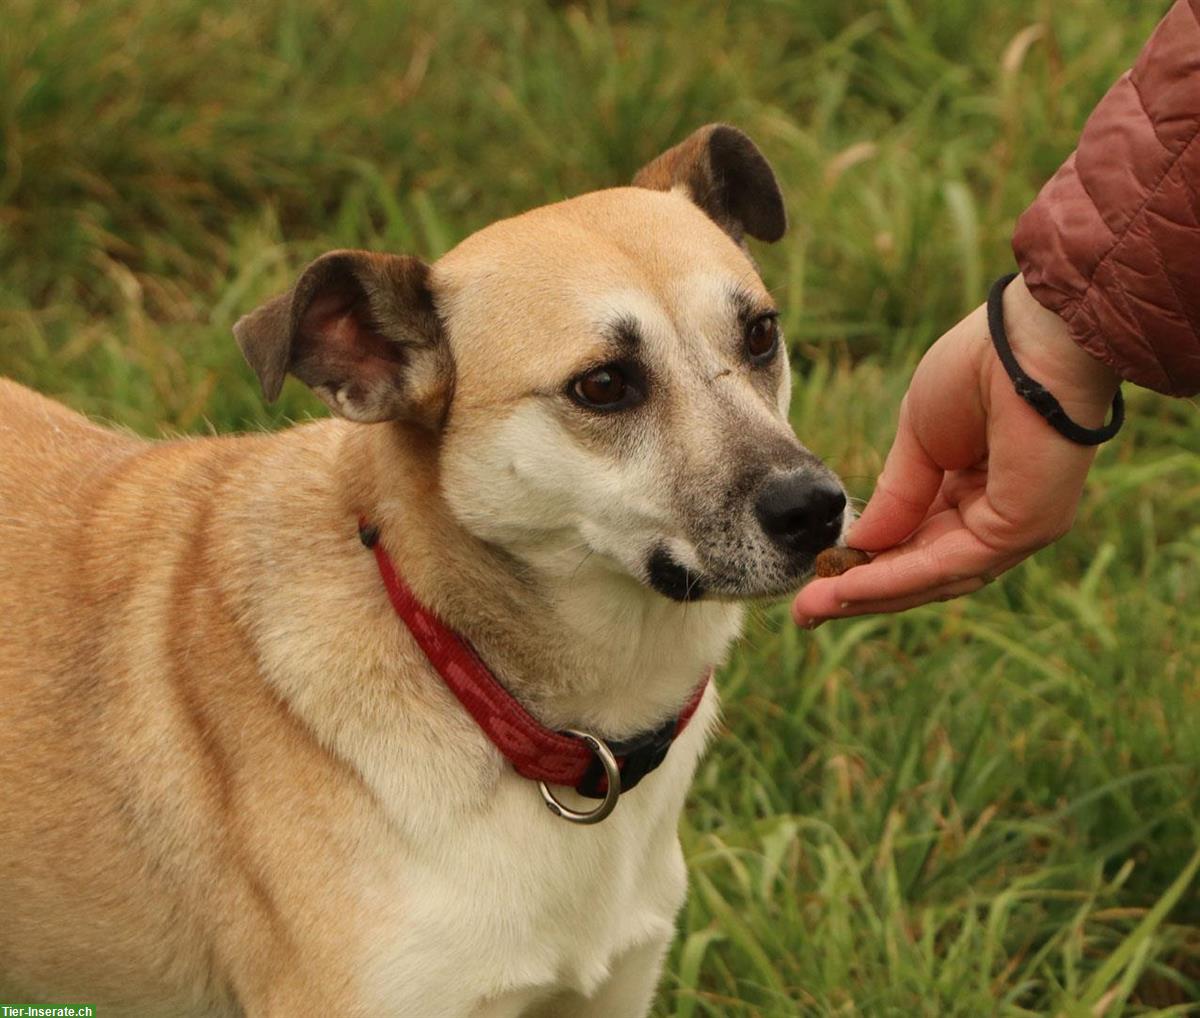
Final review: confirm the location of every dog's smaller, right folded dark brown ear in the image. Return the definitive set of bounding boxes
[634,124,787,244]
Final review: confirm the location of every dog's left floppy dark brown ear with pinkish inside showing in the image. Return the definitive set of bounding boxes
[233,251,454,427]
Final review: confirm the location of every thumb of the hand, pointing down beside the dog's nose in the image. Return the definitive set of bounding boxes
[846,397,943,551]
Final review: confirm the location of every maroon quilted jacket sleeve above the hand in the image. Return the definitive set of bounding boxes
[1013,0,1200,396]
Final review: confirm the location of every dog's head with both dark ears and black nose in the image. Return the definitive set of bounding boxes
[234,126,847,600]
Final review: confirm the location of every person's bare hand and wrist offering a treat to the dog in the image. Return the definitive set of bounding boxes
[792,277,1120,627]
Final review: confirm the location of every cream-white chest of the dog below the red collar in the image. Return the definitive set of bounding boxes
[355,761,690,1018]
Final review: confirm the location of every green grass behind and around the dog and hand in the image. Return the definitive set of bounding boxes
[0,0,1200,1018]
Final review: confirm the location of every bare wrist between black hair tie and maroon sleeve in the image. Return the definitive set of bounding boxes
[1004,276,1121,427]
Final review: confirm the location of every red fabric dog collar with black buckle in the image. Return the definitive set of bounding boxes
[359,520,710,798]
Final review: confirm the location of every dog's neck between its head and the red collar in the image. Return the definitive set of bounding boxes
[338,417,742,738]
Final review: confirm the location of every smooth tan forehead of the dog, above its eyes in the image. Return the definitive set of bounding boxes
[433,187,764,384]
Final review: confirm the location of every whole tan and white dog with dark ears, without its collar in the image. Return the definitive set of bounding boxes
[0,126,846,1018]
